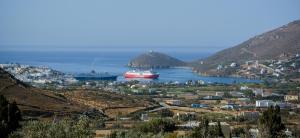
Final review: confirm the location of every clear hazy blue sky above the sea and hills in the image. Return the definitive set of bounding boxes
[0,0,300,51]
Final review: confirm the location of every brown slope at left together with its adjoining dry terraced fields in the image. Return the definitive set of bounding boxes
[0,68,156,118]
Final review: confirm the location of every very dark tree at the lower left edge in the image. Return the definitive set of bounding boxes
[0,95,22,137]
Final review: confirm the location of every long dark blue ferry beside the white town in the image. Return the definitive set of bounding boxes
[74,70,118,81]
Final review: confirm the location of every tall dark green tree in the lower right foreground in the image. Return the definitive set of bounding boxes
[259,105,285,138]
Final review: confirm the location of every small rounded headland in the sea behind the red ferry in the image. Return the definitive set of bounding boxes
[128,51,186,68]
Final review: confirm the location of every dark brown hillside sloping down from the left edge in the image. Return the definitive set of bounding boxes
[0,68,87,117]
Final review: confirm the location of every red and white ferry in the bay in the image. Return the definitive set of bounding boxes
[124,70,159,79]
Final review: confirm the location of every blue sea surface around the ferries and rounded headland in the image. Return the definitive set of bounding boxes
[0,50,260,84]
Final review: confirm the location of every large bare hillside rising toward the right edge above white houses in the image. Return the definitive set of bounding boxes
[193,20,300,74]
